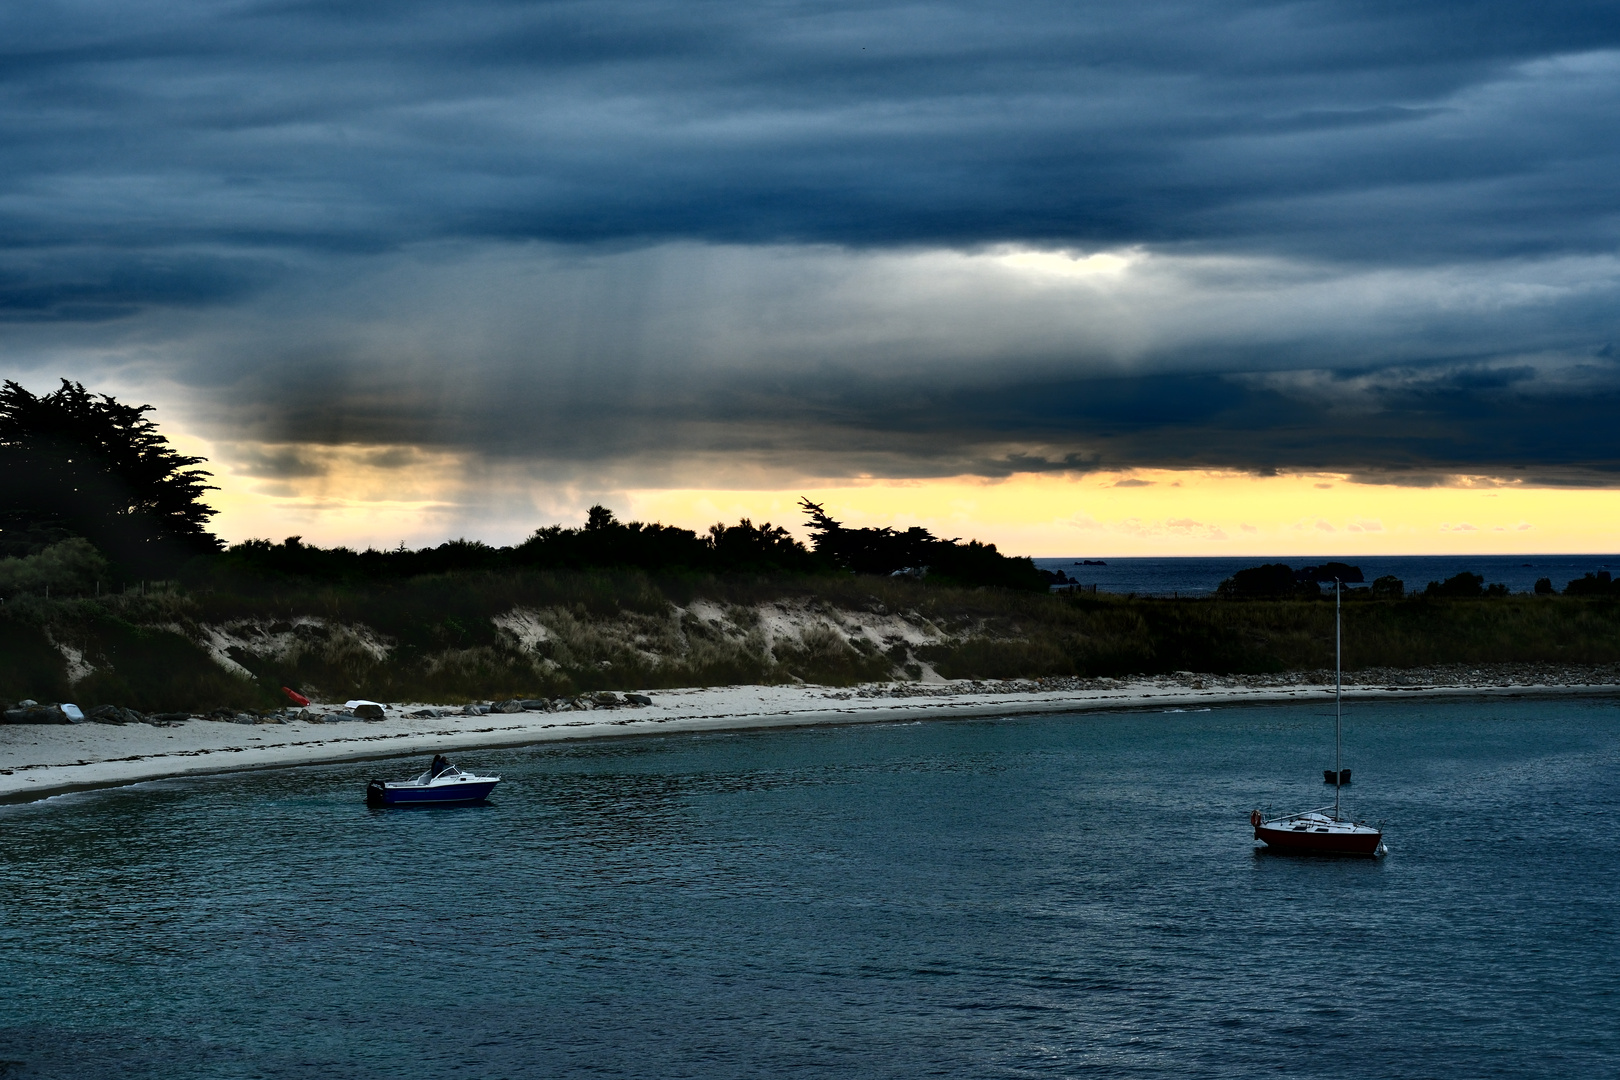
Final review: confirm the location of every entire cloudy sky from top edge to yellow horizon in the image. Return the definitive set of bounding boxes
[0,0,1620,555]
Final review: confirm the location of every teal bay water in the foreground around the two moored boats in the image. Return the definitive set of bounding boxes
[0,699,1620,1080]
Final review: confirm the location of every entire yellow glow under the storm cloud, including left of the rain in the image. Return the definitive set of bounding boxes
[192,427,1620,557]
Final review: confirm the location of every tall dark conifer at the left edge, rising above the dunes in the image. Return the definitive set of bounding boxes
[0,379,219,576]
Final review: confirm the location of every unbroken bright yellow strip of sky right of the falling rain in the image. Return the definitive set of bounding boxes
[630,471,1620,557]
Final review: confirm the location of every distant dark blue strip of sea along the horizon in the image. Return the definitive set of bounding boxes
[1035,555,1620,596]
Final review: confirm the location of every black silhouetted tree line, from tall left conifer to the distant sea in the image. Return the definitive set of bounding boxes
[0,379,1051,591]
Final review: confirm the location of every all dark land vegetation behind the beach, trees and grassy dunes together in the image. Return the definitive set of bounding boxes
[0,375,1620,711]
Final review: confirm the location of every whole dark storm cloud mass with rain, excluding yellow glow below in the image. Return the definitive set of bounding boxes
[0,0,1620,478]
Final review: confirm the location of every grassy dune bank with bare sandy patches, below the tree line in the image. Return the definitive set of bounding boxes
[0,570,1620,711]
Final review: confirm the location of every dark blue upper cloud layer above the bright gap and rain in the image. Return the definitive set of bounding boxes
[9,0,1620,268]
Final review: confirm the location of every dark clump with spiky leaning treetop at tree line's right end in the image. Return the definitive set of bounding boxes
[799,499,1048,593]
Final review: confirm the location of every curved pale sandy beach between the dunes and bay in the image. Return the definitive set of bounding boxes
[0,677,1620,805]
